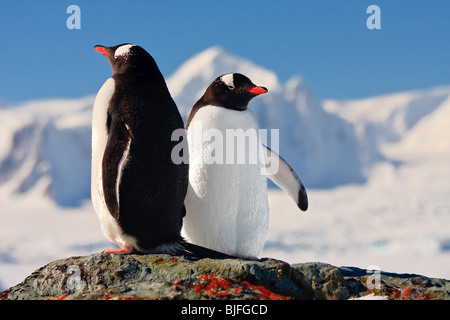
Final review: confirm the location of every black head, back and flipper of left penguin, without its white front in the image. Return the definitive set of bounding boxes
[96,45,188,251]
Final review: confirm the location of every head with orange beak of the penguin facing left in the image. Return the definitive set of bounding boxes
[94,43,159,75]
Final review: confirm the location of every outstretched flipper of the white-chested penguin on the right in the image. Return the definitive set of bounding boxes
[262,145,308,211]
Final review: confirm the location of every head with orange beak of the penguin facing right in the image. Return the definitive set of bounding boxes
[205,73,268,111]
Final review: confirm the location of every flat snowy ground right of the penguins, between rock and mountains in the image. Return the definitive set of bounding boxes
[263,160,450,279]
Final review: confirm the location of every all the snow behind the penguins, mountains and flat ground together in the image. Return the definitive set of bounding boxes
[0,47,450,290]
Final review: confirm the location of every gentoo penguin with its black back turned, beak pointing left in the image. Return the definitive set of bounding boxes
[91,44,232,255]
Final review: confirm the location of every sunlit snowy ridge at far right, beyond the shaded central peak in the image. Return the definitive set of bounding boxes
[323,86,450,157]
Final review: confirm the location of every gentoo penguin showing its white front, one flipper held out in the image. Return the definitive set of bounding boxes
[183,73,308,258]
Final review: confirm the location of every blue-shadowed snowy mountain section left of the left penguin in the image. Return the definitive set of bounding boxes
[0,97,94,206]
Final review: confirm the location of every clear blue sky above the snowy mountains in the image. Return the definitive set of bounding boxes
[0,0,450,103]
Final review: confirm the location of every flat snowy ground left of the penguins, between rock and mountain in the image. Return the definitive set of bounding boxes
[0,184,108,289]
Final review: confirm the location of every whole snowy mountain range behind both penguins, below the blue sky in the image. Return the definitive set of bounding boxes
[0,47,450,206]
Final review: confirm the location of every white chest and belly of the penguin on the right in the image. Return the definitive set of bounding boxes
[184,106,269,257]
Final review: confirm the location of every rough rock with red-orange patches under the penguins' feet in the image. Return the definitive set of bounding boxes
[0,253,450,300]
